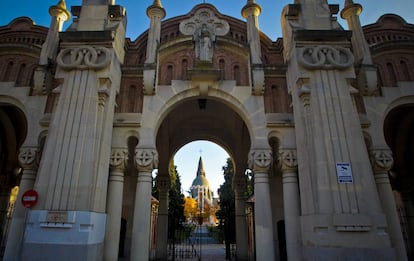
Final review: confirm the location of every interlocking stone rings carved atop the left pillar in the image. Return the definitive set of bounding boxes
[56,46,112,70]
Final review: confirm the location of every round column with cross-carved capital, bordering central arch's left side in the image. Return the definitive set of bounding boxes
[131,149,158,261]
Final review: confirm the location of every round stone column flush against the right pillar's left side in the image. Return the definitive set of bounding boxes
[279,149,302,260]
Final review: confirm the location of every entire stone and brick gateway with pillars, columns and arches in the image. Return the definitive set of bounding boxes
[0,0,414,261]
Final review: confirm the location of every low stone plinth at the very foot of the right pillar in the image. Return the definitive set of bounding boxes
[302,247,397,261]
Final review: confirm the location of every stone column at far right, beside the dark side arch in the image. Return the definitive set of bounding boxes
[371,149,407,261]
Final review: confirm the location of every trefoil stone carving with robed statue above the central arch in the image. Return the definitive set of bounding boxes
[180,8,230,62]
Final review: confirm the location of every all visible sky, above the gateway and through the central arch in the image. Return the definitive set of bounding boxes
[0,0,414,196]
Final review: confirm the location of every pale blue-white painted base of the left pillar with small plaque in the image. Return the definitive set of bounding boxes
[21,210,106,261]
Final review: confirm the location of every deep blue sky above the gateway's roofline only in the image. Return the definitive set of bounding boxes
[0,0,414,40]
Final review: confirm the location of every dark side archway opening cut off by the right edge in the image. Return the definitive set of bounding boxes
[384,103,414,260]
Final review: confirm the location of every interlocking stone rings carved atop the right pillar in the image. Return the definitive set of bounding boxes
[298,46,354,70]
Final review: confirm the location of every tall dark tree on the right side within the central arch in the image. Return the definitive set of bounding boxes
[217,158,236,259]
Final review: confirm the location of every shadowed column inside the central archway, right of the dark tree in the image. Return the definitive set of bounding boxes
[233,174,248,261]
